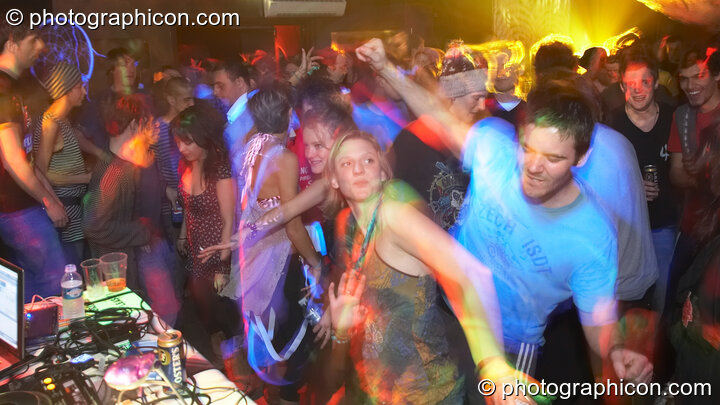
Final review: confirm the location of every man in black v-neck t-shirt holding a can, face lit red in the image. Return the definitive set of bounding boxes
[609,46,676,311]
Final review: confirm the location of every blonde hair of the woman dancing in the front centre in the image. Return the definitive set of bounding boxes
[322,130,393,218]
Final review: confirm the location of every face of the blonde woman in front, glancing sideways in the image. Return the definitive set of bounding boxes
[330,139,387,202]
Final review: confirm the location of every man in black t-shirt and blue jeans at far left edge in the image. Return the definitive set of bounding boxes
[0,20,67,301]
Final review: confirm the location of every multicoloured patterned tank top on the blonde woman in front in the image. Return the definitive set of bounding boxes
[336,197,464,404]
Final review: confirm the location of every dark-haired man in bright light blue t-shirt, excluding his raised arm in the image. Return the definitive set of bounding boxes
[455,82,652,381]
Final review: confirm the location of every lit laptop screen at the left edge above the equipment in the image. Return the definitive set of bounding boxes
[0,259,24,355]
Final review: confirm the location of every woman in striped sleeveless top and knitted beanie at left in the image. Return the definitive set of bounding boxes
[33,62,102,264]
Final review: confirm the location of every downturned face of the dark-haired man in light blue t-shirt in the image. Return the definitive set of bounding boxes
[518,124,579,207]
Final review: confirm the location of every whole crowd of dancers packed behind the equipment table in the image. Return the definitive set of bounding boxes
[0,15,720,404]
